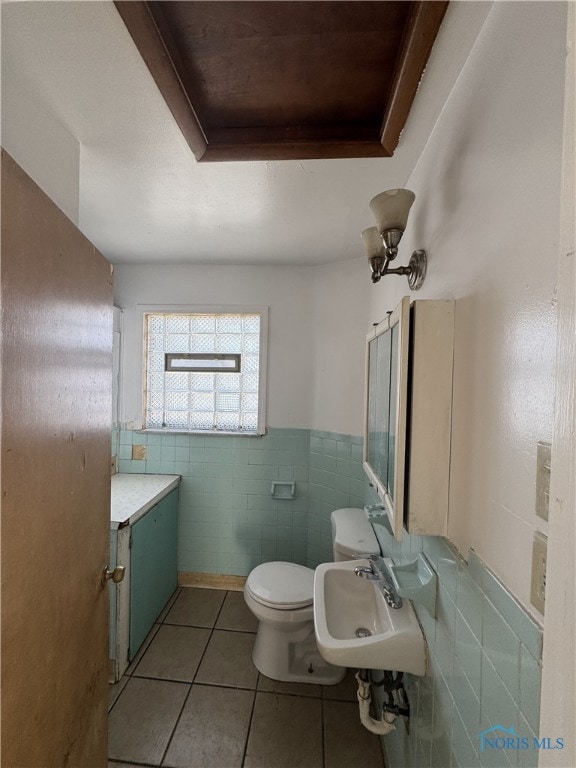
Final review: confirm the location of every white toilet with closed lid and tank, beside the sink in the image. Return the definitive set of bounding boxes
[244,509,380,685]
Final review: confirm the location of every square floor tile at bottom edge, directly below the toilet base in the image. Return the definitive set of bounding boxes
[244,692,322,768]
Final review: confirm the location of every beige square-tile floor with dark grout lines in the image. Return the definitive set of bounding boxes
[108,587,383,768]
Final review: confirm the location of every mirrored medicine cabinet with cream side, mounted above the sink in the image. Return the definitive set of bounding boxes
[364,297,454,540]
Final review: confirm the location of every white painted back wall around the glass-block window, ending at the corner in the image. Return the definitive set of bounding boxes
[114,265,316,429]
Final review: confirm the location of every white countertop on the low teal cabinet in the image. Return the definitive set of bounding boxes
[110,474,181,528]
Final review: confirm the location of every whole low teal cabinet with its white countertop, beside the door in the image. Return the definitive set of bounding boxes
[109,474,180,681]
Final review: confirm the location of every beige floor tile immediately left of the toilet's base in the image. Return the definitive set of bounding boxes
[195,629,258,688]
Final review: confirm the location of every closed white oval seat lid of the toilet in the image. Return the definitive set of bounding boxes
[246,561,314,611]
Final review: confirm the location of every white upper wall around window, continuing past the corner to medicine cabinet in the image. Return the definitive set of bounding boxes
[114,258,370,435]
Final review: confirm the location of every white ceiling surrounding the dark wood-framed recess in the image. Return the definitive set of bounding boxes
[2,0,490,264]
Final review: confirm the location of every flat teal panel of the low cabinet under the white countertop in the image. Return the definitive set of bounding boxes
[129,490,178,659]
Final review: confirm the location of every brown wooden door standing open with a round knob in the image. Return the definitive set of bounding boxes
[1,153,112,768]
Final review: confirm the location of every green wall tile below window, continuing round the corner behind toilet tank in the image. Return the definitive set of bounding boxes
[118,428,365,576]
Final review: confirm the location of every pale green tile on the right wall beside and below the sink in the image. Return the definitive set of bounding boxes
[367,491,544,768]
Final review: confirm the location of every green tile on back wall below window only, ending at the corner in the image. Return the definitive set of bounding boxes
[119,429,310,576]
